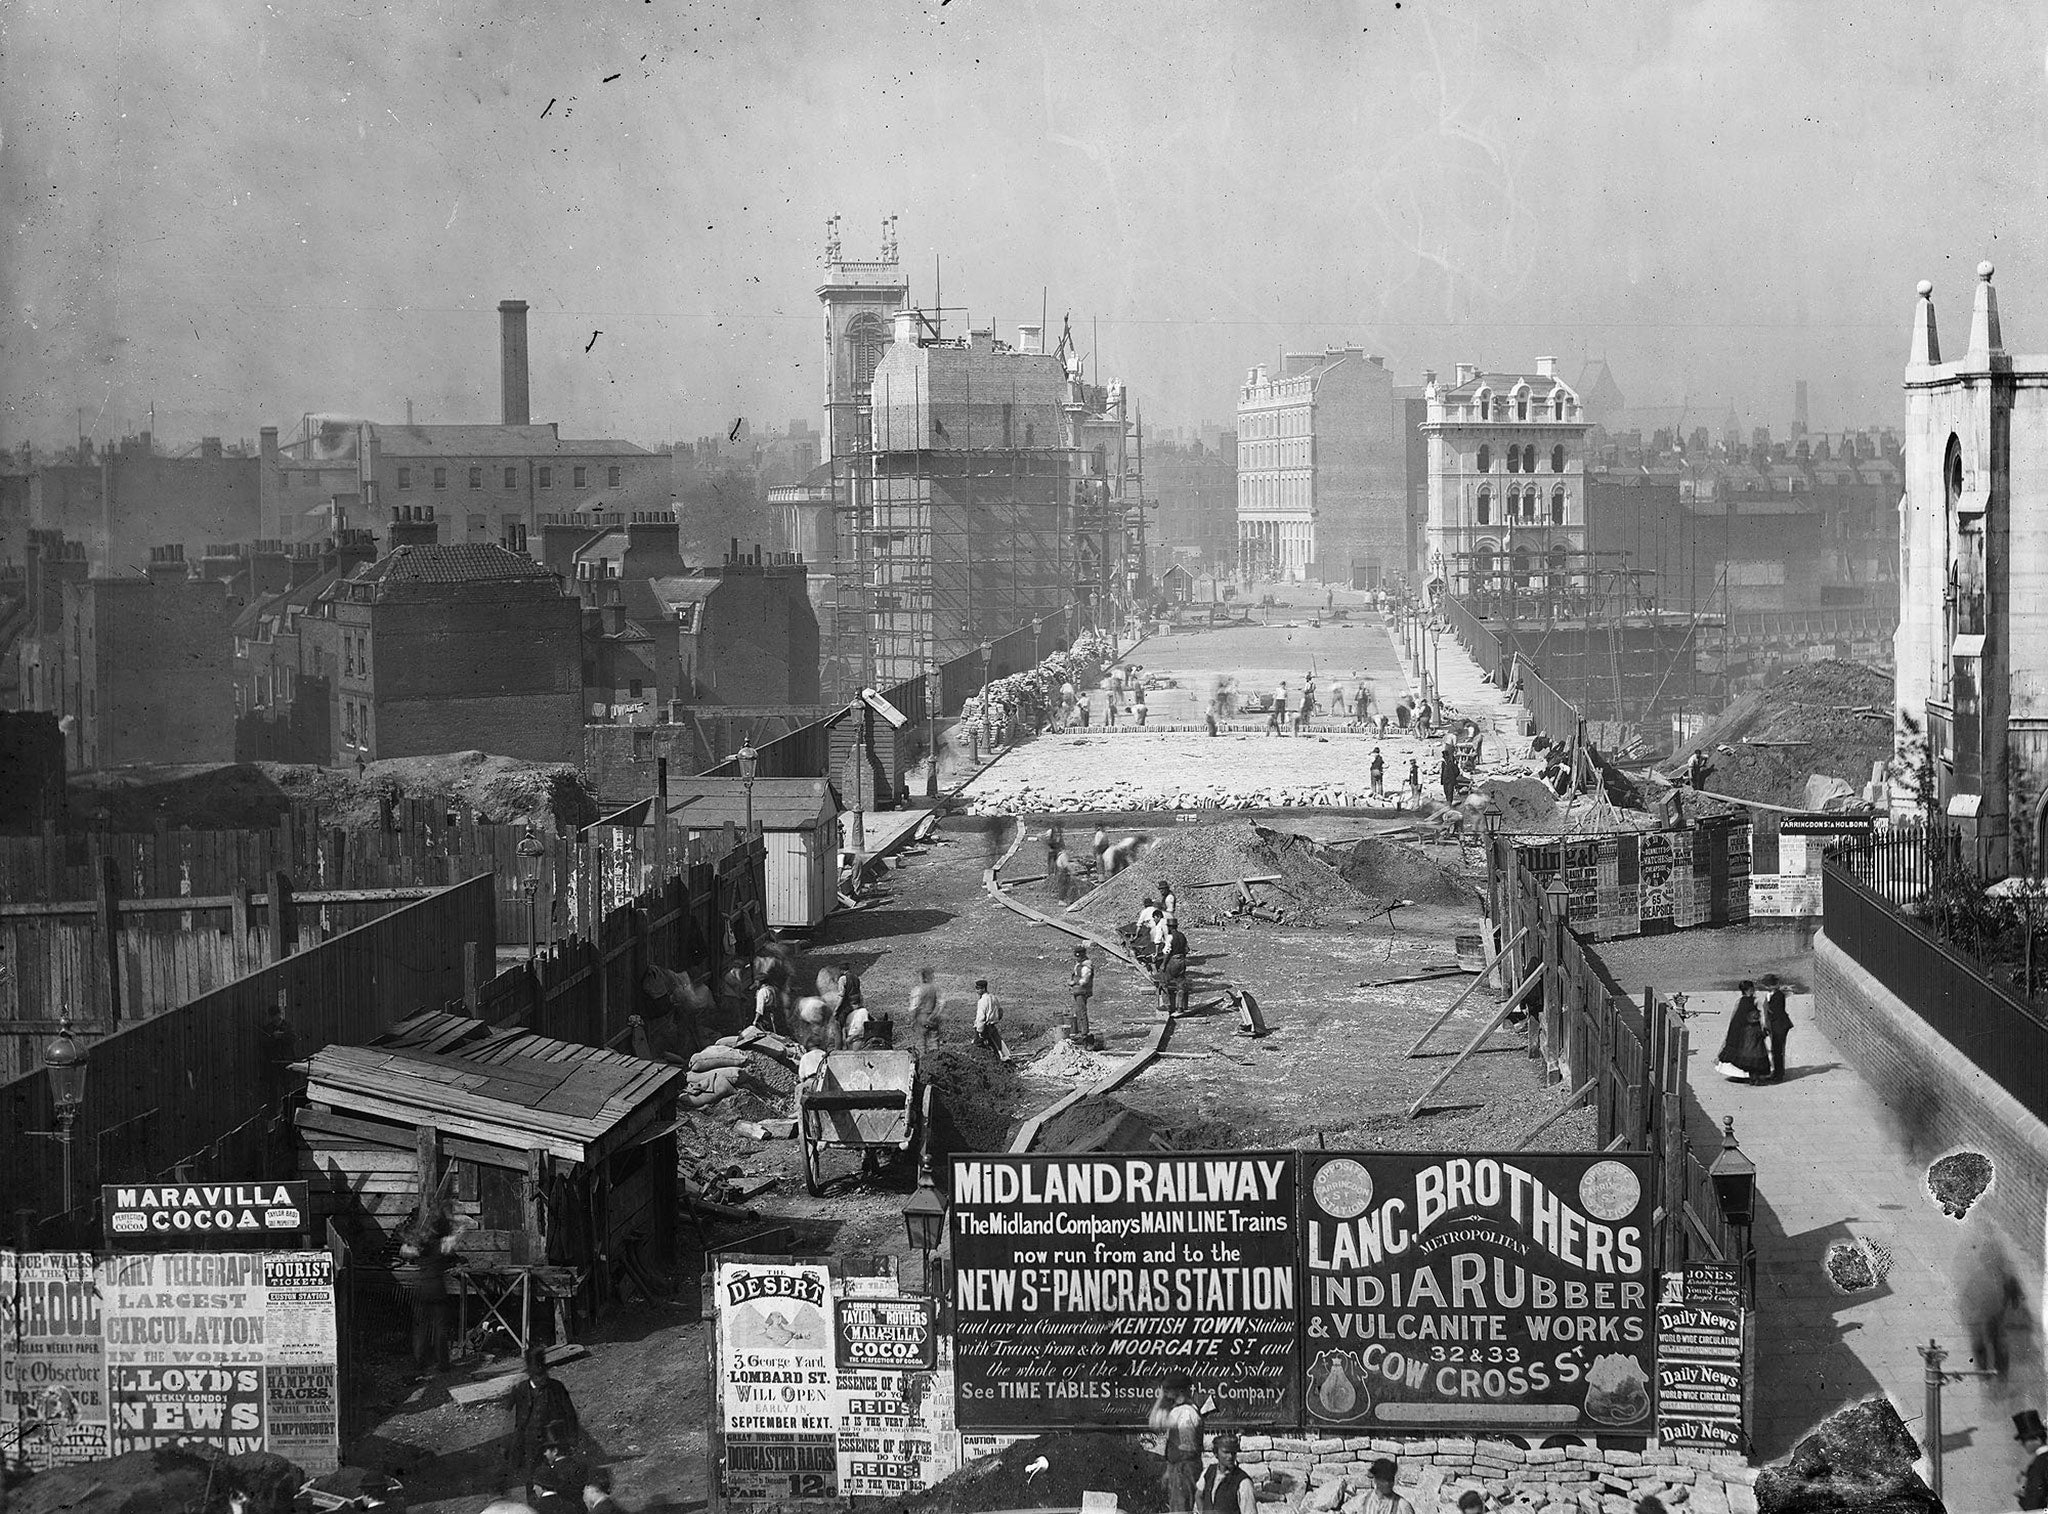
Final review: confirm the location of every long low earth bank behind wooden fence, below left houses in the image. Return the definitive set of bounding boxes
[70,752,598,830]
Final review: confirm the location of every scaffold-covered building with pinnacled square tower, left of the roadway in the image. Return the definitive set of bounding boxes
[798,223,1147,697]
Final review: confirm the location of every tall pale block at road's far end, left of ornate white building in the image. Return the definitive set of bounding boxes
[1237,346,1411,586]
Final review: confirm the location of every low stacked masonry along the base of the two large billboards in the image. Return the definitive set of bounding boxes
[1241,1434,1757,1514]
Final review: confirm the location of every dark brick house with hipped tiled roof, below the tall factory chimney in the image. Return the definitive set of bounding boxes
[299,508,584,764]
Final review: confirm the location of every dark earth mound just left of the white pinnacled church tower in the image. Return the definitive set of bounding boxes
[1667,660,1892,809]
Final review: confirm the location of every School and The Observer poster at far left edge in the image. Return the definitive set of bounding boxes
[0,1252,106,1471]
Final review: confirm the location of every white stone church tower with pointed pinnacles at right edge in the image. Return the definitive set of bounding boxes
[1892,262,2048,873]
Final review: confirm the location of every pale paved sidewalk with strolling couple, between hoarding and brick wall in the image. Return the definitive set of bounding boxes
[1679,987,2025,1514]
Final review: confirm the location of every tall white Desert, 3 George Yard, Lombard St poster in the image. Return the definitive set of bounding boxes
[715,1262,840,1510]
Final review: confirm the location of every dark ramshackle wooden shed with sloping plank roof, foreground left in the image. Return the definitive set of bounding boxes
[295,1012,686,1334]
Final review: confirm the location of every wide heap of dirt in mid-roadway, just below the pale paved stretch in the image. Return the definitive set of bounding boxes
[1075,819,1370,926]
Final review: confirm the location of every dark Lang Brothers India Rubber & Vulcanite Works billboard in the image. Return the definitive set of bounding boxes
[1300,1151,1655,1434]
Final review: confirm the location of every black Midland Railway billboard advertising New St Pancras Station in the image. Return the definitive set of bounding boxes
[950,1151,1300,1432]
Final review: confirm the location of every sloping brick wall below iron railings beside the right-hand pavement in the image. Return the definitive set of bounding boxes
[1812,932,2048,1319]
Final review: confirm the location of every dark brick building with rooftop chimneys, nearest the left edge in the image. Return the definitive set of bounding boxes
[20,543,240,768]
